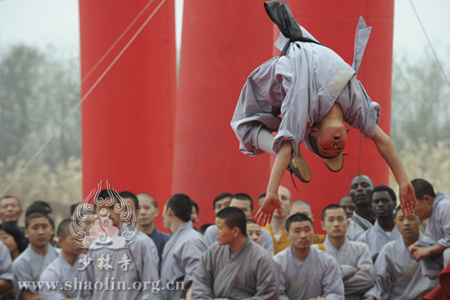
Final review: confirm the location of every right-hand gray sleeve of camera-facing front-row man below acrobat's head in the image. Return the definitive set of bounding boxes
[322,257,344,300]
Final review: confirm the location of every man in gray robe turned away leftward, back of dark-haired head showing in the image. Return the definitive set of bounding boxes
[161,194,208,300]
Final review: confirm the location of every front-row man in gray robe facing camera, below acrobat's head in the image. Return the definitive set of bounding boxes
[274,214,344,300]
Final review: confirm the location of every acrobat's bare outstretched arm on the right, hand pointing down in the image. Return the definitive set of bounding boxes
[373,125,417,215]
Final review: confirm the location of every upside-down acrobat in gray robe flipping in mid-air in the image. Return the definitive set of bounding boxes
[231,0,416,224]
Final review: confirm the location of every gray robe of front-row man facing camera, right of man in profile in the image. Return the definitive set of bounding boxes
[273,246,344,300]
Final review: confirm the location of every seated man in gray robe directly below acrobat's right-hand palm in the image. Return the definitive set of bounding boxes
[365,208,438,300]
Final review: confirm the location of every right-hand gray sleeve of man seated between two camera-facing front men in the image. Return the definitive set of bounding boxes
[344,244,374,294]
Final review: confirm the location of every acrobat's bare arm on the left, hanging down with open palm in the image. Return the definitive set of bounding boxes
[255,141,292,226]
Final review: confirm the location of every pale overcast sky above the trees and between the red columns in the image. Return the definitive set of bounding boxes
[0,0,450,61]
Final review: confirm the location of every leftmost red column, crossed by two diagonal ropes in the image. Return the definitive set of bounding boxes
[78,0,176,218]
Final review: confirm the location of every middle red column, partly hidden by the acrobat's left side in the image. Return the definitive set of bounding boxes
[173,0,273,223]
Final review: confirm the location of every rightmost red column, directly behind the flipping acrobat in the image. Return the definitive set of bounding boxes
[283,0,394,231]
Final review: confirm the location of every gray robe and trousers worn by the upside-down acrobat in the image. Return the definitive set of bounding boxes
[231,18,380,157]
